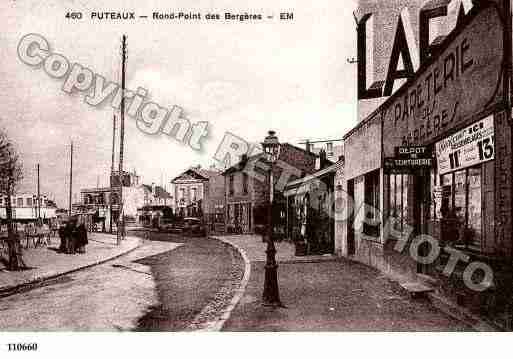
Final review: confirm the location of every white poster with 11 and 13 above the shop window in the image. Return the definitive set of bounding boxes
[435,116,495,174]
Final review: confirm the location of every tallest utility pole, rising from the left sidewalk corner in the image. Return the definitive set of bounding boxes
[117,35,126,244]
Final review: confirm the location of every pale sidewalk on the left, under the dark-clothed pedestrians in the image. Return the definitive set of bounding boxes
[0,233,141,296]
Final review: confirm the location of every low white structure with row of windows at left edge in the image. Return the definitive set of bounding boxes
[0,193,57,222]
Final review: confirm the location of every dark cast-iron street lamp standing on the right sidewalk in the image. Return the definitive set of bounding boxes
[262,131,282,307]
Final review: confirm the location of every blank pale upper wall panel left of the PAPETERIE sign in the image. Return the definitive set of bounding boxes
[344,115,381,179]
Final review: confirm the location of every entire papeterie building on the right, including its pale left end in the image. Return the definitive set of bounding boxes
[336,1,513,328]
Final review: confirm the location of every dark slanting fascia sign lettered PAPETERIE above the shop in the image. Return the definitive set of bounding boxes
[381,6,503,157]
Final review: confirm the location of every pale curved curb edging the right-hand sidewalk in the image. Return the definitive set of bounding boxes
[189,237,251,332]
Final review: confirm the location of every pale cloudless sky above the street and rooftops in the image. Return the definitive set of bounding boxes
[0,0,357,208]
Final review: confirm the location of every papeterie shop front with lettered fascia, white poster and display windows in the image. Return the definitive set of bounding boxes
[380,2,504,264]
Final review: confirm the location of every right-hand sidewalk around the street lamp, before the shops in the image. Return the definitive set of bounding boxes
[216,236,472,331]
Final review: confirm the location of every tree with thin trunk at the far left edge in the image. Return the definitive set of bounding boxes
[0,130,25,270]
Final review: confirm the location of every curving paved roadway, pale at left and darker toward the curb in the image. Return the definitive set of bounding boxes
[0,233,241,331]
